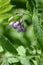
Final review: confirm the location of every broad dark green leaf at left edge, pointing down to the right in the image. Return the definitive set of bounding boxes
[0,34,17,55]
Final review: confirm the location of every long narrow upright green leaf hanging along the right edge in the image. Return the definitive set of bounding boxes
[32,11,43,50]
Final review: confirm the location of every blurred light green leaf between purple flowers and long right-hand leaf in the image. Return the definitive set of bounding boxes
[26,25,37,46]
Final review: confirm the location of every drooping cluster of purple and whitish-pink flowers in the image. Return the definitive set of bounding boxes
[9,19,26,32]
